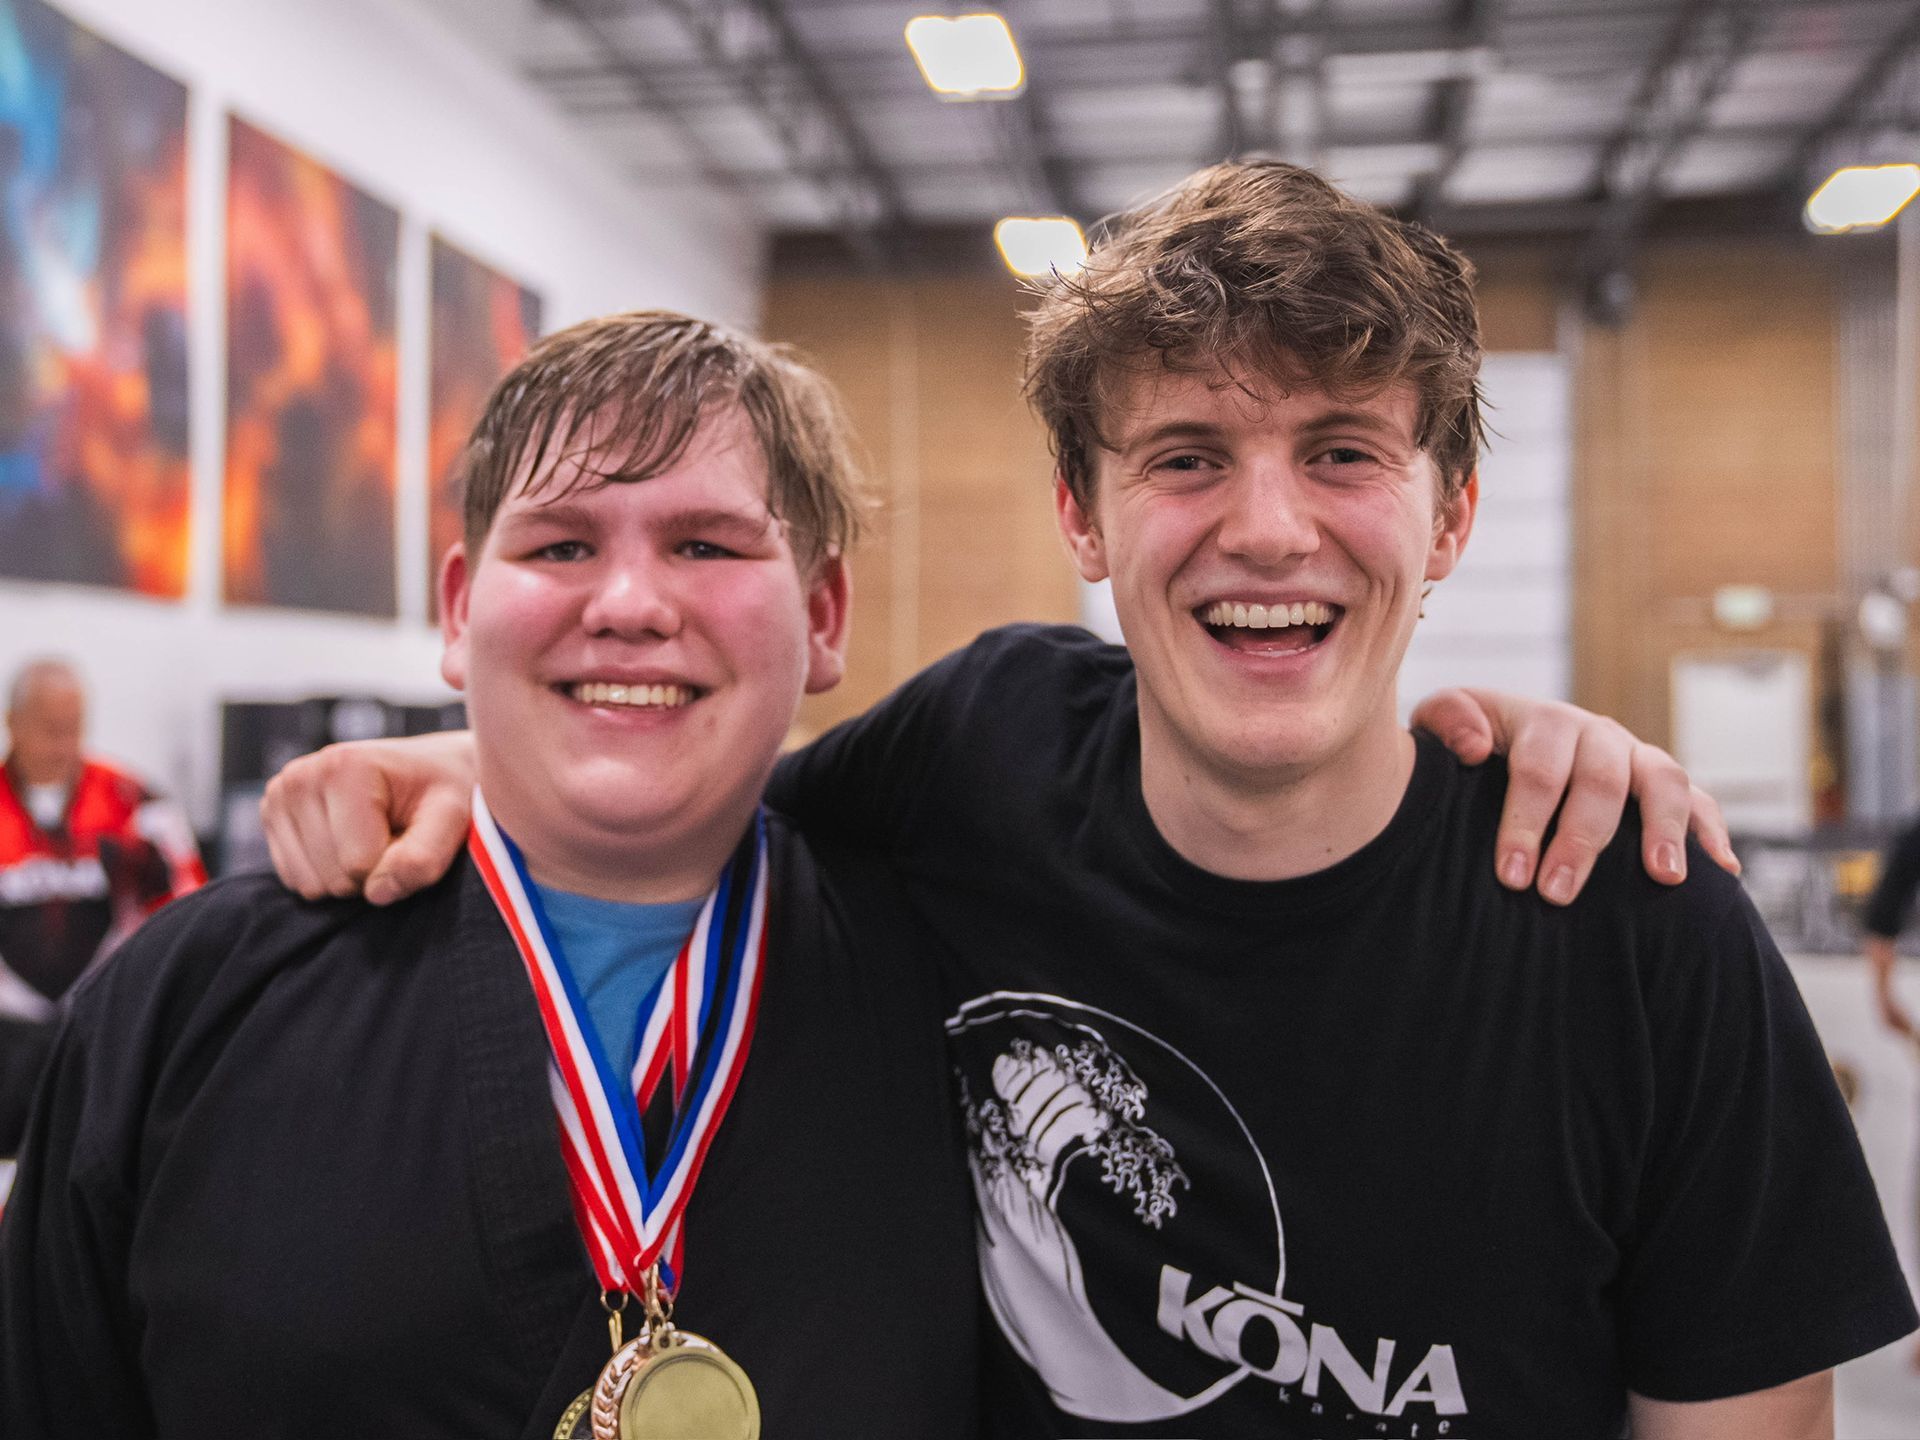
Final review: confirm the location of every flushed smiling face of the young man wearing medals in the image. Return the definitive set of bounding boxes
[442,407,849,900]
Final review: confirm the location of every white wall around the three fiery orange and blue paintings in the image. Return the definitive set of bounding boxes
[0,0,764,826]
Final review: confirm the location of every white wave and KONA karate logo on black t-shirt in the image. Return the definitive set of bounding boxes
[947,993,1467,1440]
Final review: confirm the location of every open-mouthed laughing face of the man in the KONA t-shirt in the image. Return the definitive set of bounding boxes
[1058,369,1476,795]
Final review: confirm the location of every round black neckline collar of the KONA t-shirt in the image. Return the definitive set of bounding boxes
[1125,720,1451,912]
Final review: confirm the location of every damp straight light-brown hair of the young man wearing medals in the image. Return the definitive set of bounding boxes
[461,309,860,564]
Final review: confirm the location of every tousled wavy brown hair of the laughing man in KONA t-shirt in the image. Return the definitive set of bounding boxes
[1025,159,1484,507]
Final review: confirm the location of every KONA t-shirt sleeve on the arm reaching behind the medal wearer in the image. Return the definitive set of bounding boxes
[766,643,977,852]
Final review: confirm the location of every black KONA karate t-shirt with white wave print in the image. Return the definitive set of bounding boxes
[776,628,1914,1440]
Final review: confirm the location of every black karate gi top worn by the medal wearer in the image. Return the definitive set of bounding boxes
[0,822,979,1440]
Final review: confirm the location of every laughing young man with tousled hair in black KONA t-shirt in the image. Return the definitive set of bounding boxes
[259,161,1914,1440]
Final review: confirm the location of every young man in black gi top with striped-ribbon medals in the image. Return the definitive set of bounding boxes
[0,313,979,1440]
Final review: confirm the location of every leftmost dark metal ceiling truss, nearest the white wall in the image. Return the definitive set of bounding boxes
[543,0,910,263]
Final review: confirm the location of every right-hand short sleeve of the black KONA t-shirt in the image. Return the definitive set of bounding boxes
[1619,898,1916,1402]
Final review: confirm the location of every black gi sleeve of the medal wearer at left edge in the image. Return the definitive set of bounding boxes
[0,1010,154,1440]
